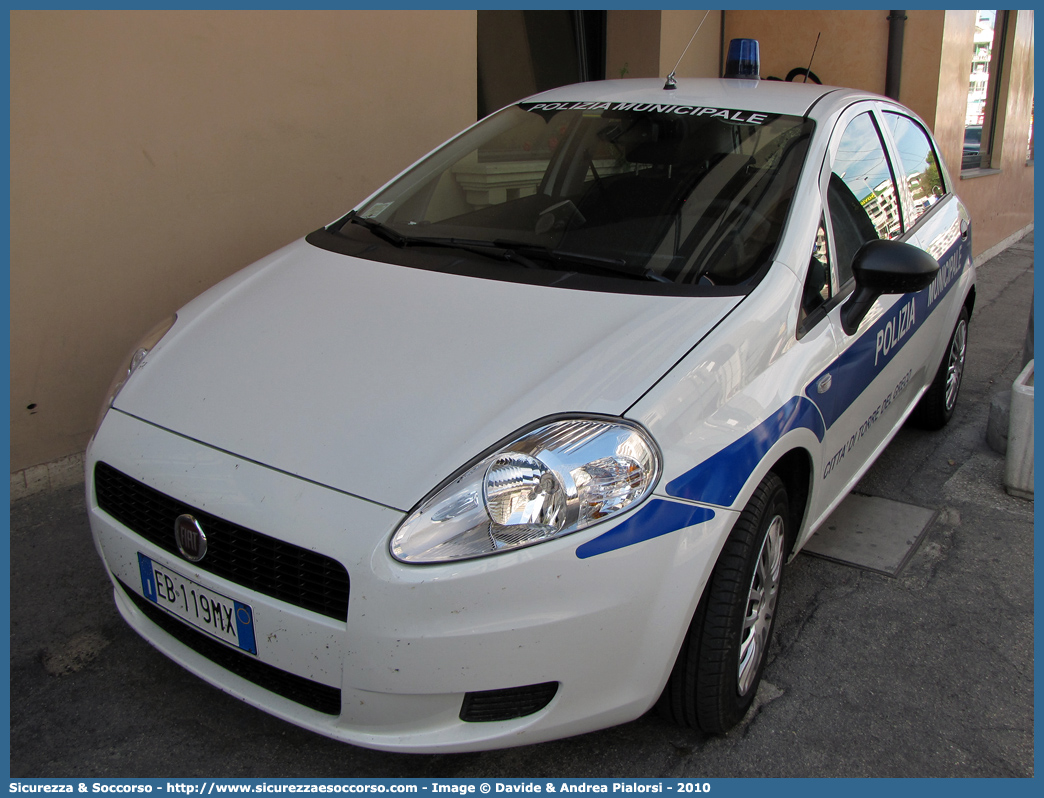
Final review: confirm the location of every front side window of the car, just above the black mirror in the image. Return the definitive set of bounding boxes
[827,113,903,285]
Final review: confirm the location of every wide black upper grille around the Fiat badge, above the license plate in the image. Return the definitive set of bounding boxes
[94,463,349,620]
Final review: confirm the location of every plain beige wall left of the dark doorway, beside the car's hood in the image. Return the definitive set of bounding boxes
[10,10,476,474]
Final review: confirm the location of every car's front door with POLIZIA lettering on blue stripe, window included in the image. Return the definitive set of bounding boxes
[806,101,951,526]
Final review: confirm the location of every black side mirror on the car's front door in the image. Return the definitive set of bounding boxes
[841,238,939,335]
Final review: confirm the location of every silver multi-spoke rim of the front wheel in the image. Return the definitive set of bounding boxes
[737,515,783,696]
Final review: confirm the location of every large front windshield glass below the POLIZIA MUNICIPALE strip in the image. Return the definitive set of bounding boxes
[331,102,812,286]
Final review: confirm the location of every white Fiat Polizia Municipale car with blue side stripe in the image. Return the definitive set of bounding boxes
[87,59,975,751]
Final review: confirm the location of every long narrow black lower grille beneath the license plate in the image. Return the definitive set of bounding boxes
[117,580,340,714]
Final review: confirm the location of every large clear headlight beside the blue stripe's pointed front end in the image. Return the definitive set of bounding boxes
[390,418,661,563]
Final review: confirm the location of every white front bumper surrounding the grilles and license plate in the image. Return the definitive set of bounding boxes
[87,410,735,752]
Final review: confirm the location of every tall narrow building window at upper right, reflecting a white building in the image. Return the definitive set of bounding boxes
[960,10,1009,171]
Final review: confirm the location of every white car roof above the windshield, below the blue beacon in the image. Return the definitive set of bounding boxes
[523,77,892,116]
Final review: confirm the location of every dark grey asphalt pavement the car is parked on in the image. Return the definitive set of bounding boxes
[10,233,1034,778]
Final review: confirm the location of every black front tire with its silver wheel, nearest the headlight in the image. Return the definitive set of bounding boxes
[659,473,790,733]
